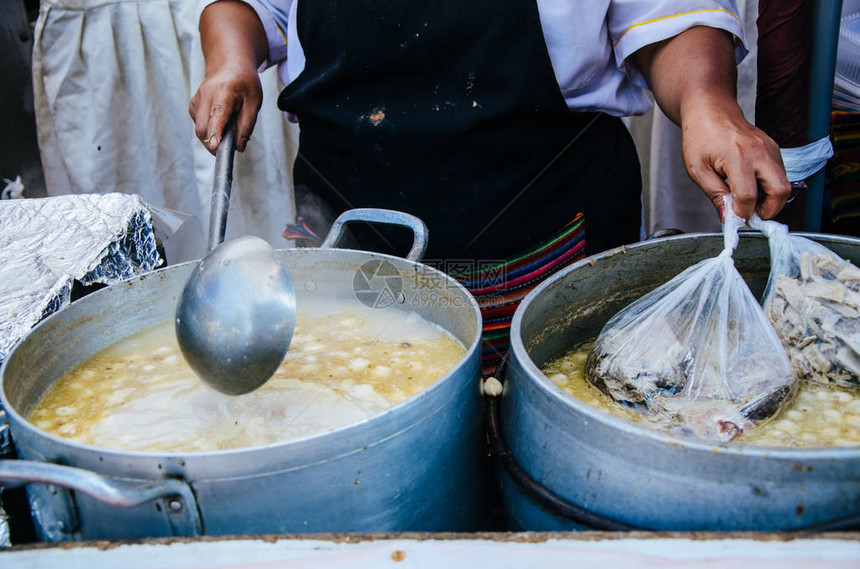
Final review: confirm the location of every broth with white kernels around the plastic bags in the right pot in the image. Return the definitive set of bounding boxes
[541,342,860,447]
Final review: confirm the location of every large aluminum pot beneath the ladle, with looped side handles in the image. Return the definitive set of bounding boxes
[0,210,484,541]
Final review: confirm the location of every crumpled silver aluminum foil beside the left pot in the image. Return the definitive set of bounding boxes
[0,193,163,364]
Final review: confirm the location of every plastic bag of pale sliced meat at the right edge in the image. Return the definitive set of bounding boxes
[750,217,860,389]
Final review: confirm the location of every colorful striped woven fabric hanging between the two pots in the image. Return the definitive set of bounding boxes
[449,213,585,377]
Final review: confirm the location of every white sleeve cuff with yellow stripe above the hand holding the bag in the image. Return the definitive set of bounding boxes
[607,0,747,87]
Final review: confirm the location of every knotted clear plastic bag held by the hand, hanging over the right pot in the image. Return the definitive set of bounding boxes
[587,200,796,441]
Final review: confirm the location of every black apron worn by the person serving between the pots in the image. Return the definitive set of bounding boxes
[278,0,641,260]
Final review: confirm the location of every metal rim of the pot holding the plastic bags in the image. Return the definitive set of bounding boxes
[511,232,860,461]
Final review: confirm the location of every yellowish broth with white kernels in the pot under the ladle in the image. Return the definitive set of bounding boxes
[29,301,466,452]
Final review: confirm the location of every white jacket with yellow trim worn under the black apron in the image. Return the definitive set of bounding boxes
[222,0,746,116]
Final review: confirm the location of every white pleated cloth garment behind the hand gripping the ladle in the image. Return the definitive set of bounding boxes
[33,0,297,255]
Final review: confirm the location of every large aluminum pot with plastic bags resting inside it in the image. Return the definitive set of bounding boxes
[499,233,860,531]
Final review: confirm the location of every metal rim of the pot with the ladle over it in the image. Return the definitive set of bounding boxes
[0,248,481,460]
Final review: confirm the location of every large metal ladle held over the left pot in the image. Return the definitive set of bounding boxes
[176,121,296,395]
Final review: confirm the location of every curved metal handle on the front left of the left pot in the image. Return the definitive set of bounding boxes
[0,459,203,535]
